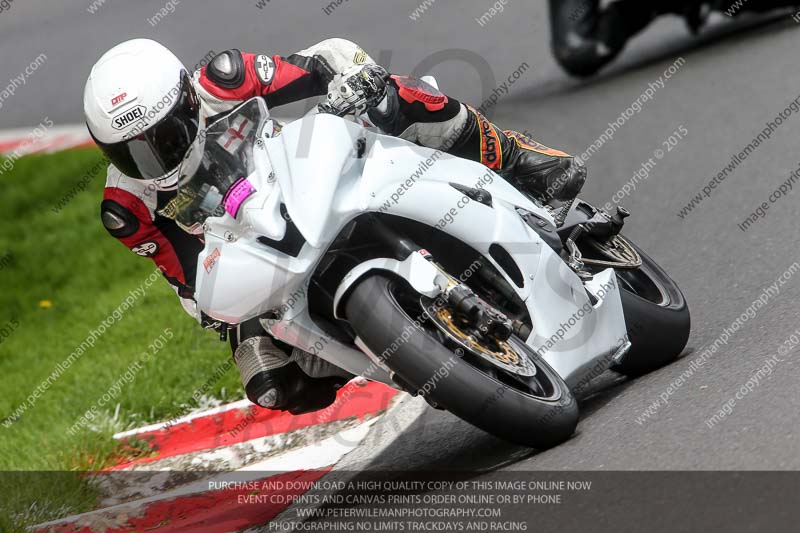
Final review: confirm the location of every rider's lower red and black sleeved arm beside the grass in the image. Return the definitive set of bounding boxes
[100,167,203,318]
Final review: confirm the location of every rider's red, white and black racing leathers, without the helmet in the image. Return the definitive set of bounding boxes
[101,39,585,413]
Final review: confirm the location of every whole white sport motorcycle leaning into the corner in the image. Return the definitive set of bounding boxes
[170,98,689,448]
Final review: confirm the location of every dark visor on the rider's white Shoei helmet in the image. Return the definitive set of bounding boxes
[92,71,200,180]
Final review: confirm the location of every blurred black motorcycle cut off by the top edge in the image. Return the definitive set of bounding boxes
[550,0,798,77]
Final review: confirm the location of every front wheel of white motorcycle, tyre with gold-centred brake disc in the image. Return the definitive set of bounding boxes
[345,274,578,449]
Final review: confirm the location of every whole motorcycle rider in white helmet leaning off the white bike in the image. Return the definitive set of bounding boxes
[84,39,586,414]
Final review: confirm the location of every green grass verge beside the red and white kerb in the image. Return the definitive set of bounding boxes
[0,149,243,531]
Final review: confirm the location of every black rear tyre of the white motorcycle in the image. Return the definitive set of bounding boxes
[612,241,691,377]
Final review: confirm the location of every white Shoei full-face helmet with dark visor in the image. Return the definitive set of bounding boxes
[83,39,200,181]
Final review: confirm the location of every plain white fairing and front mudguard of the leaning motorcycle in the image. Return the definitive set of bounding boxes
[196,110,627,386]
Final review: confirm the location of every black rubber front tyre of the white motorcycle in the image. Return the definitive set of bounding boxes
[345,274,578,449]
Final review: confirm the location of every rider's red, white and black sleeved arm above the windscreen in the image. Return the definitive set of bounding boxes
[195,39,375,112]
